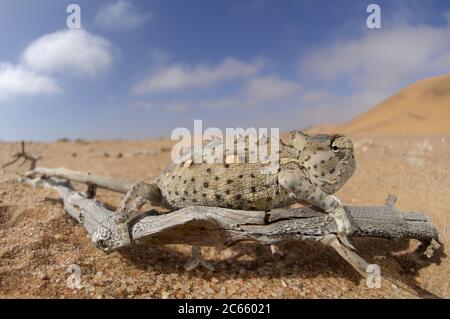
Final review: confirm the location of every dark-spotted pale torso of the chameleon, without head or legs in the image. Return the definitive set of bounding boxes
[156,163,289,210]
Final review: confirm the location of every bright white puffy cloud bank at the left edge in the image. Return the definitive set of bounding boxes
[0,30,112,99]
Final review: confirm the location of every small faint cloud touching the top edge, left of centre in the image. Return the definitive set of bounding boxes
[95,0,151,30]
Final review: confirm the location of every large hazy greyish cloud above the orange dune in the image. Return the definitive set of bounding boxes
[300,25,450,90]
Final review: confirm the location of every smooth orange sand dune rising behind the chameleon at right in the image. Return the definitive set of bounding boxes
[340,75,450,134]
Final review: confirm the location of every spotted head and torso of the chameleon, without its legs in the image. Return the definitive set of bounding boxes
[156,132,356,214]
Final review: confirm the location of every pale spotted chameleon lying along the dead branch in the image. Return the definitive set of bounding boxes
[116,130,356,270]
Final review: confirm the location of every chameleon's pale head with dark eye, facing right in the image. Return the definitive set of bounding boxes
[288,131,356,194]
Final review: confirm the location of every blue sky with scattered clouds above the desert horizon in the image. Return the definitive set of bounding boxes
[0,0,450,141]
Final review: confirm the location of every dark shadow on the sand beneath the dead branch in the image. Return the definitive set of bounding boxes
[120,238,445,298]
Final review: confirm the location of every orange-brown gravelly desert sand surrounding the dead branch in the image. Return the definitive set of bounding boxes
[0,135,450,298]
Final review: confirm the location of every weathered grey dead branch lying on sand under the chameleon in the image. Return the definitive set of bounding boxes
[20,168,439,276]
